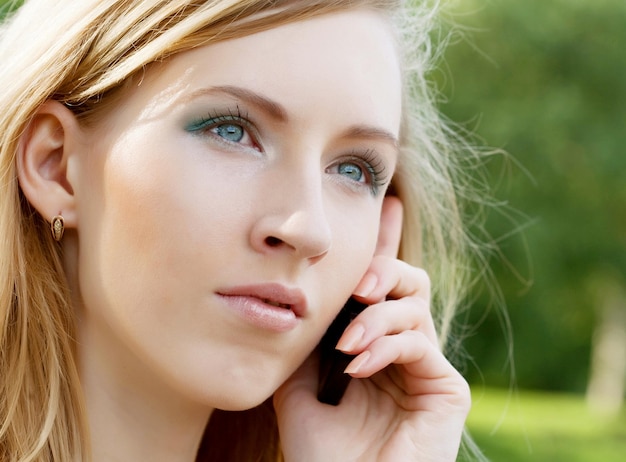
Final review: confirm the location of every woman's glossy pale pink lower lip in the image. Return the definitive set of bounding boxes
[218,294,299,332]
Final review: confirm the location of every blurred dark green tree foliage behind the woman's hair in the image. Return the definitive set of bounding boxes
[437,0,626,391]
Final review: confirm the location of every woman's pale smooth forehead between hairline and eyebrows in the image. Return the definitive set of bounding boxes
[102,9,402,134]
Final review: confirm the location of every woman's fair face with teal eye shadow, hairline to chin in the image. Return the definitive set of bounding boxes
[66,10,401,409]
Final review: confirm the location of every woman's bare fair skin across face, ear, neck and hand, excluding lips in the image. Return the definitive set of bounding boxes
[15,10,469,462]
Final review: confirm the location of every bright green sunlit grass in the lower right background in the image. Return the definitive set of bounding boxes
[468,389,626,462]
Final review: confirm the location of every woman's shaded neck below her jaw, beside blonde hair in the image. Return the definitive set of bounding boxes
[78,322,211,462]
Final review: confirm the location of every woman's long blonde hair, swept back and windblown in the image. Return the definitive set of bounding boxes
[0,0,486,462]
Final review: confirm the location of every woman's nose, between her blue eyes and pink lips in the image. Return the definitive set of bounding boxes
[250,169,332,264]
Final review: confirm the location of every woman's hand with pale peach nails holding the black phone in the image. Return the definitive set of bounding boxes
[274,197,470,462]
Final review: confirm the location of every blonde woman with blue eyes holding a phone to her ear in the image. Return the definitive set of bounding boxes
[0,0,486,462]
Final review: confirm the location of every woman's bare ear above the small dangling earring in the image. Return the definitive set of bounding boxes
[17,101,81,227]
